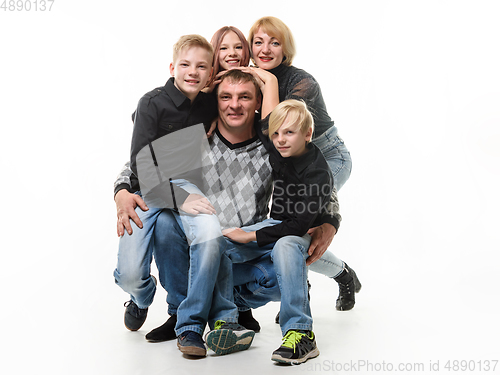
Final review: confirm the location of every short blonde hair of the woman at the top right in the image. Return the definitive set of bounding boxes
[248,17,295,66]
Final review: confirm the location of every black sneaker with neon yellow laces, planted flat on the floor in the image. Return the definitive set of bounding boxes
[271,330,319,365]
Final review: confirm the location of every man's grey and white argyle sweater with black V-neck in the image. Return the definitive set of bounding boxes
[114,121,341,229]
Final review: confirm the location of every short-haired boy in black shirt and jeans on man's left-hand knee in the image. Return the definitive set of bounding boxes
[114,35,230,356]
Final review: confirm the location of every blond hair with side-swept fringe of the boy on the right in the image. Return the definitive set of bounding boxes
[269,99,314,142]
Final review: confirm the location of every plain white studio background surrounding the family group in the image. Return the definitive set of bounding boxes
[0,0,500,375]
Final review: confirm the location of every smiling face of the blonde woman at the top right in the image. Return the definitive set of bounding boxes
[252,29,284,70]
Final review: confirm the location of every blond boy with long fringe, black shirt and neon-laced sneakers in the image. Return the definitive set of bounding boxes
[206,100,342,364]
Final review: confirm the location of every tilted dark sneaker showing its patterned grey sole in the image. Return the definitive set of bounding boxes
[205,320,255,355]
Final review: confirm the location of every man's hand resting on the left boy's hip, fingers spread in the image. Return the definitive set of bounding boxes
[115,189,149,237]
